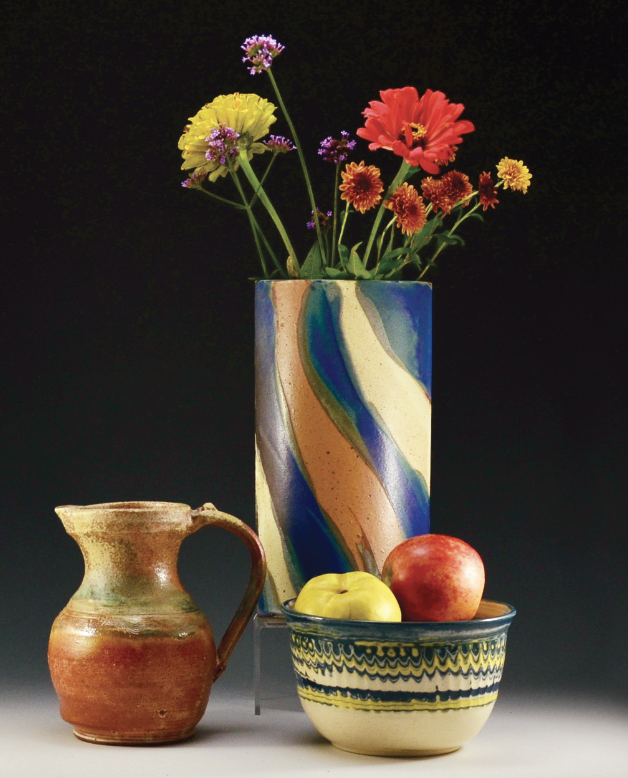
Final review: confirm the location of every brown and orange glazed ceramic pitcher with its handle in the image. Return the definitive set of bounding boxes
[48,502,266,744]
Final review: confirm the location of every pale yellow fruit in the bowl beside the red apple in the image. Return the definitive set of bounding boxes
[294,571,401,621]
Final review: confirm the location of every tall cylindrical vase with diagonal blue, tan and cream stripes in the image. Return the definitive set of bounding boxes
[255,280,432,615]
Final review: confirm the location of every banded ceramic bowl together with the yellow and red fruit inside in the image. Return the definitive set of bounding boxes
[282,534,515,756]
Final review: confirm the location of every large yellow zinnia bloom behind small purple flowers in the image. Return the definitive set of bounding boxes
[179,92,277,181]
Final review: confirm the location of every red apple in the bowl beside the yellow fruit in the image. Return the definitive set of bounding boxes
[382,535,484,621]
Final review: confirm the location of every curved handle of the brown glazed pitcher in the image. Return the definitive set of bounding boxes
[191,502,266,681]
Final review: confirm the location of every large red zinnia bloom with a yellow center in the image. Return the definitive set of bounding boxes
[357,86,475,173]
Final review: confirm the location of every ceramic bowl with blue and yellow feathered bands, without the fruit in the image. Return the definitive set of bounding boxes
[282,599,516,756]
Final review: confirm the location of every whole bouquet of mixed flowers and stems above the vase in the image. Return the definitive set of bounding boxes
[179,35,531,280]
